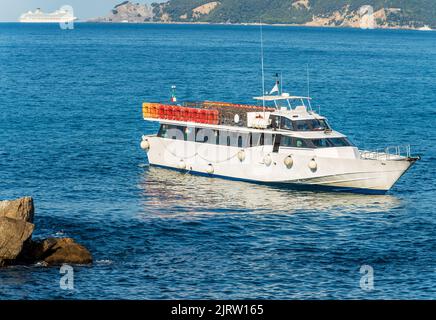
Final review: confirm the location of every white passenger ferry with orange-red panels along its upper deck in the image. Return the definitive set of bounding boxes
[140,86,419,194]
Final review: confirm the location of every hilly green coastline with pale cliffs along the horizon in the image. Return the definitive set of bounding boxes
[88,0,436,29]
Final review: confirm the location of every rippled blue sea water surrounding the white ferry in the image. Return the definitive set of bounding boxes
[0,24,436,299]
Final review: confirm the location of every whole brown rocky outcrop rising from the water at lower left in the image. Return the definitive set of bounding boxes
[0,197,92,267]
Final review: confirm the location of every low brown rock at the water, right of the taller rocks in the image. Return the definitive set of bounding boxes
[24,238,92,265]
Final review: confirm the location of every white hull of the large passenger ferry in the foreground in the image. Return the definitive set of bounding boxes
[142,136,417,194]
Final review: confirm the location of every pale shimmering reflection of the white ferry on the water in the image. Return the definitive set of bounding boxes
[139,166,401,217]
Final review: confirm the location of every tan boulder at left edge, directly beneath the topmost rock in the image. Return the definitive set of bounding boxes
[0,216,35,266]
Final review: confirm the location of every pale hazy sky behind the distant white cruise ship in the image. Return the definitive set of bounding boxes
[0,0,163,22]
